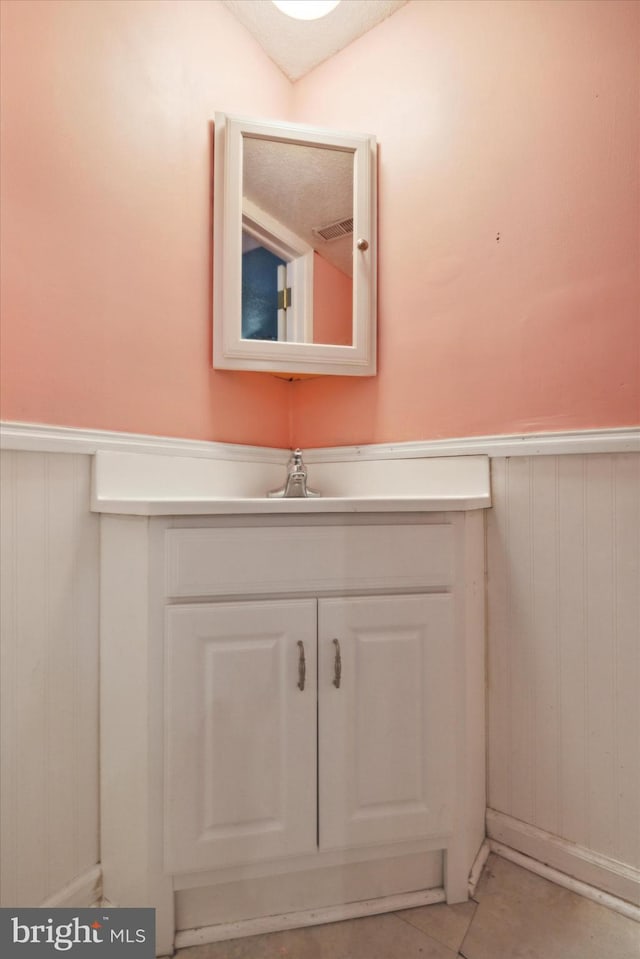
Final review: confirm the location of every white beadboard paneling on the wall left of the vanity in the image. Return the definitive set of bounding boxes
[0,452,99,906]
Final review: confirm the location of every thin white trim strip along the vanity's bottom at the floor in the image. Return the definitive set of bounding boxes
[175,888,446,949]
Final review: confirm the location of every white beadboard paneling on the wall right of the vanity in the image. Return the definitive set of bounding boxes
[487,453,640,867]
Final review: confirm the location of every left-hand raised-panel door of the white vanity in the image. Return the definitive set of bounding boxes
[164,600,317,872]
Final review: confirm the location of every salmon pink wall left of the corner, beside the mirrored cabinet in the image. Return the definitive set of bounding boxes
[0,0,291,446]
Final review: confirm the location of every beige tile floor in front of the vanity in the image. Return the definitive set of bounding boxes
[176,855,640,959]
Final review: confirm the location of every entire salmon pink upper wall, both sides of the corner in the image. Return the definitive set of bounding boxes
[0,0,640,446]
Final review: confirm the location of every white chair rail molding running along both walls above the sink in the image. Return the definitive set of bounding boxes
[0,422,640,463]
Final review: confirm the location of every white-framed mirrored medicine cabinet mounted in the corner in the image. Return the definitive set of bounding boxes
[213,114,376,376]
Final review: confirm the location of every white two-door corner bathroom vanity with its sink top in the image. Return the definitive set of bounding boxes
[93,454,489,955]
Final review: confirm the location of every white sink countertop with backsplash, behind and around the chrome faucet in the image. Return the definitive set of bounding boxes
[91,451,491,516]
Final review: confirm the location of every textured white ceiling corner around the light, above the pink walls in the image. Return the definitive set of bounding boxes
[223,0,407,80]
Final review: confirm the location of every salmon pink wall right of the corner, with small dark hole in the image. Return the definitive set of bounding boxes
[292,0,640,446]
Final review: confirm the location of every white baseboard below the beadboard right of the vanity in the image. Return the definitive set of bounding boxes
[487,809,640,918]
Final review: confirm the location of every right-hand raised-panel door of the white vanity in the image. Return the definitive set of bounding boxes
[318,594,456,849]
